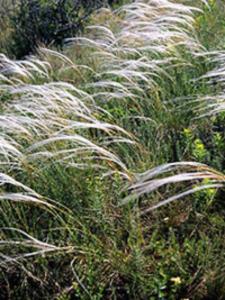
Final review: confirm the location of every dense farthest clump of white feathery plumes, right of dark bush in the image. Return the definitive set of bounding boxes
[65,0,202,110]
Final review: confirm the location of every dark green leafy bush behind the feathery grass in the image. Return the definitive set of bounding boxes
[7,0,118,58]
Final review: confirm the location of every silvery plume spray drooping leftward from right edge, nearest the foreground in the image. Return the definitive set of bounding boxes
[122,162,225,214]
